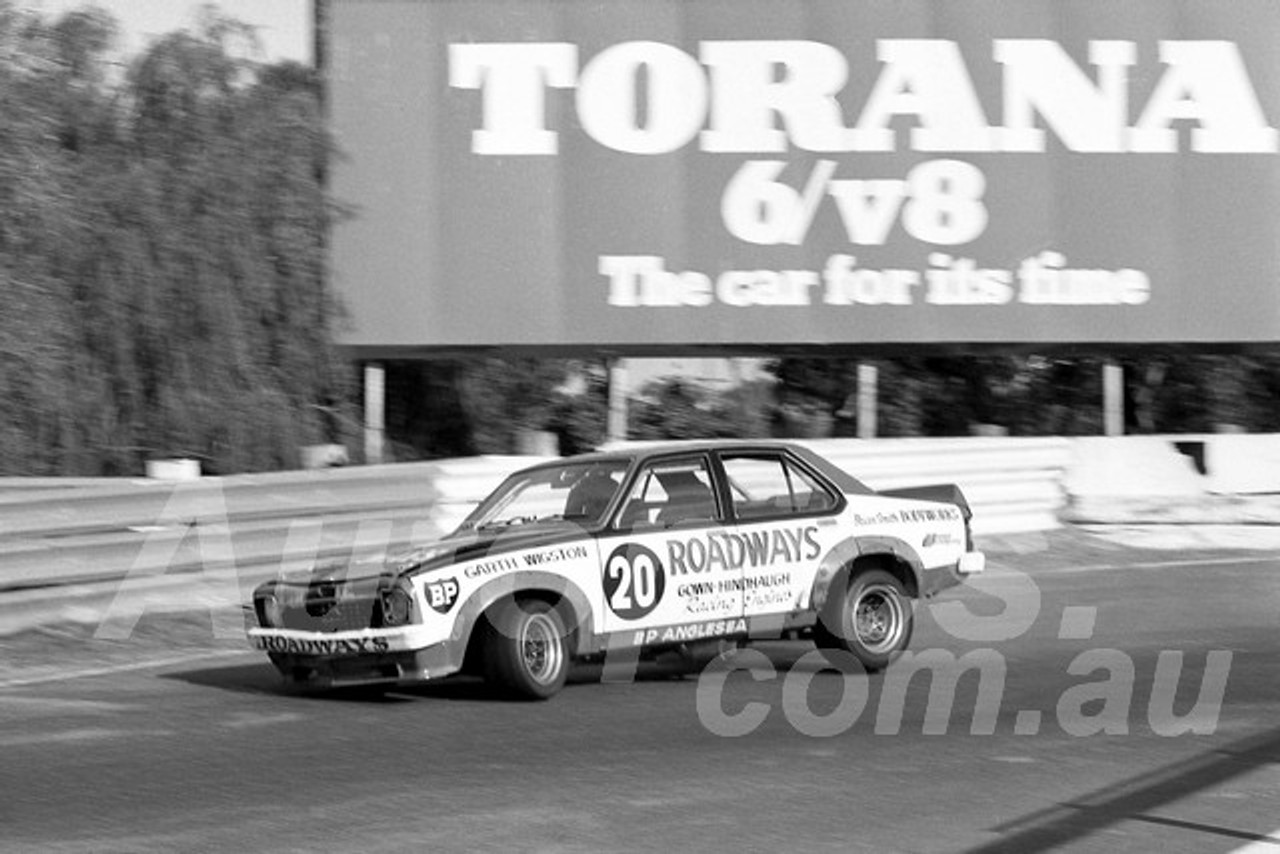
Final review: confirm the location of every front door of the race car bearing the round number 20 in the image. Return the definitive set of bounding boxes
[599,455,742,645]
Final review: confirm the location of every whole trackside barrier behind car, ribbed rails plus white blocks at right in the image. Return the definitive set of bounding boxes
[10,434,1280,599]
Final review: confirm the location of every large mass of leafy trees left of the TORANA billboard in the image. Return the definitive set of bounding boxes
[0,0,355,474]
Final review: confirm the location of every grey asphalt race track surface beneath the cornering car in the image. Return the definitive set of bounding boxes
[0,534,1280,854]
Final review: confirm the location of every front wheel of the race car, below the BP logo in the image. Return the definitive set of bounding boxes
[484,599,568,700]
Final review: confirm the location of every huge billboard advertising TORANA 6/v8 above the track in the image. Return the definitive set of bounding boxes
[326,0,1280,353]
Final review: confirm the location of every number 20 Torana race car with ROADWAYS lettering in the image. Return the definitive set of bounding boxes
[248,442,984,699]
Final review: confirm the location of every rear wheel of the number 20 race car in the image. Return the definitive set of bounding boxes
[814,570,915,672]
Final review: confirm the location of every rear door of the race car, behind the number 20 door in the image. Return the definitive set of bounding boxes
[719,449,841,620]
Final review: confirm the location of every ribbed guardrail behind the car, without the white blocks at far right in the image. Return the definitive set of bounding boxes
[0,439,1070,599]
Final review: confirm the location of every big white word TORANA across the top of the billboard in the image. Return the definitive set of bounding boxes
[449,38,1280,155]
